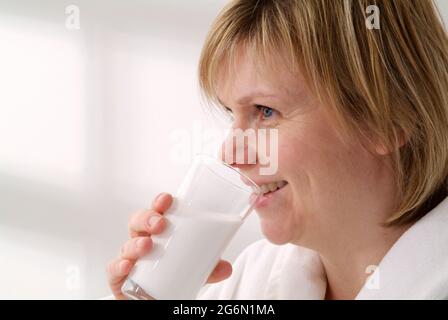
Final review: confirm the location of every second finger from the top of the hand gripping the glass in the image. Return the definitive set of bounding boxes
[128,210,165,238]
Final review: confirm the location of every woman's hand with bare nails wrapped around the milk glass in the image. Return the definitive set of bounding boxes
[107,193,232,300]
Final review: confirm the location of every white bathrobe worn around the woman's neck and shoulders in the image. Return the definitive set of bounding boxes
[198,198,448,299]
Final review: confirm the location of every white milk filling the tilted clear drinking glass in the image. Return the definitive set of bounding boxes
[129,208,242,299]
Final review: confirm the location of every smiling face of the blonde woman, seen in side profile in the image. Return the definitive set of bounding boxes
[218,51,394,248]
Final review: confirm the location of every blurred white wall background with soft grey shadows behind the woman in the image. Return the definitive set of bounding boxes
[0,0,448,299]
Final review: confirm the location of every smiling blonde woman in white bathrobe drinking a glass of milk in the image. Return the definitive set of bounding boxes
[108,0,448,299]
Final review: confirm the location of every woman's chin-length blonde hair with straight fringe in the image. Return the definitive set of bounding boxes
[199,0,448,225]
